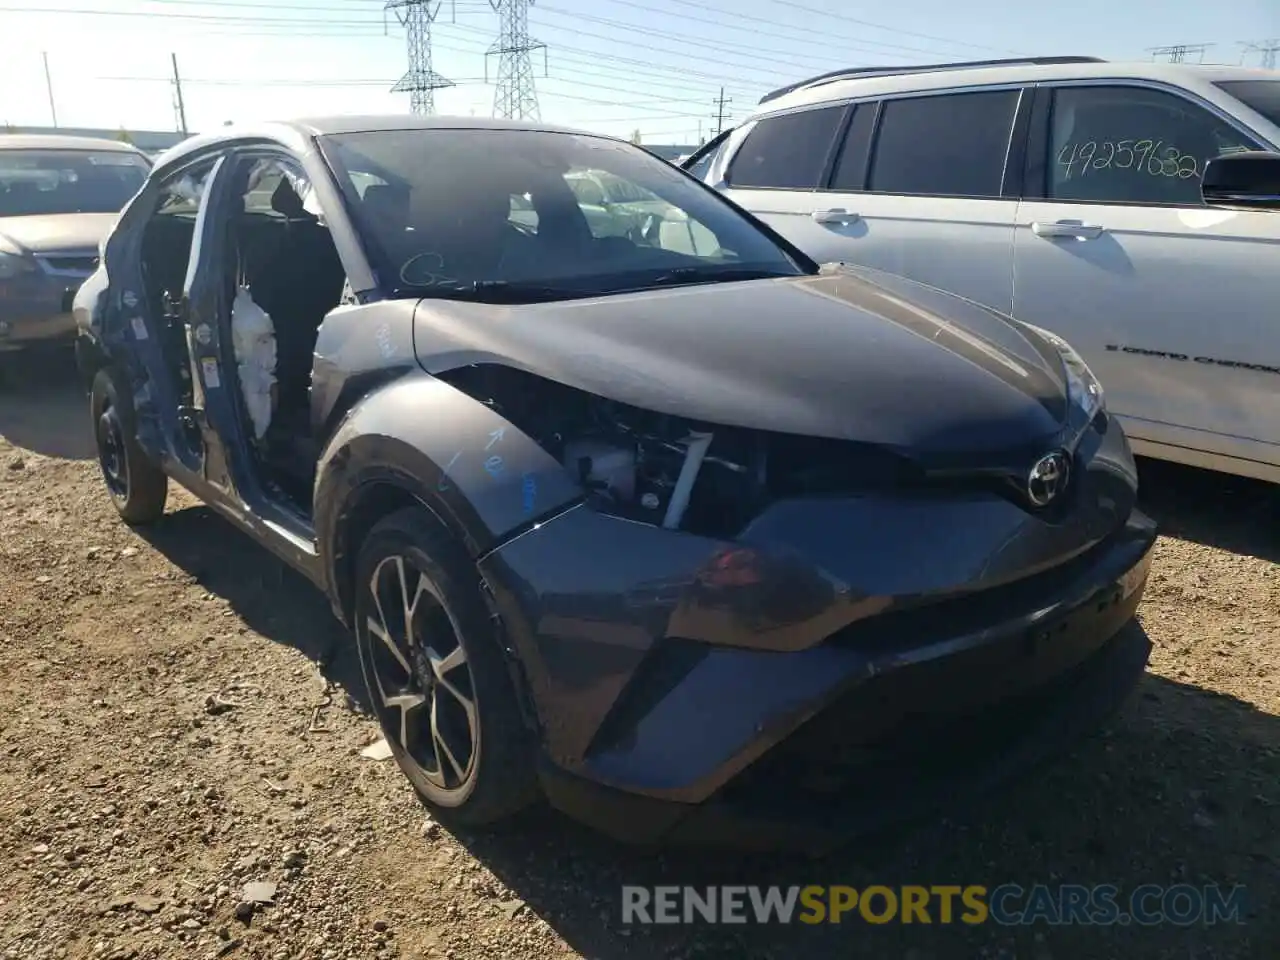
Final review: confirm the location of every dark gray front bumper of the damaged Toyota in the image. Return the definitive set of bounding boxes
[479,409,1156,838]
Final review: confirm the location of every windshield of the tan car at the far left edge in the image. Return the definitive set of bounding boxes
[0,148,150,216]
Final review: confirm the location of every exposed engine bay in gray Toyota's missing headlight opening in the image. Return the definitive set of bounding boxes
[442,364,920,536]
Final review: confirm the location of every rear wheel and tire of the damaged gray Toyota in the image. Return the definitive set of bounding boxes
[90,367,169,525]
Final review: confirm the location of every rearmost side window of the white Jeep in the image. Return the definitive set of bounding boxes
[728,106,845,189]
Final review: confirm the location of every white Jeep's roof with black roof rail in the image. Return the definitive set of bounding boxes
[759,58,1280,114]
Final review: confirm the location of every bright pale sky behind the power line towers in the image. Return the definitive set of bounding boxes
[0,0,1280,143]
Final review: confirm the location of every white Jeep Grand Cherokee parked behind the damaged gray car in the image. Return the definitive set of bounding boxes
[684,56,1280,481]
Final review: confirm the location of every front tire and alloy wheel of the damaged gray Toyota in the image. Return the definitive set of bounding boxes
[355,508,538,826]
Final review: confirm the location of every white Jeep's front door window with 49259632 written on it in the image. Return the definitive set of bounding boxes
[1044,87,1254,206]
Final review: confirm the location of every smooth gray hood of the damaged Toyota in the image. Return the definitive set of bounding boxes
[413,268,1066,453]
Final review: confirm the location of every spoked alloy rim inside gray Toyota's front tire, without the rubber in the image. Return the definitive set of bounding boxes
[365,556,480,801]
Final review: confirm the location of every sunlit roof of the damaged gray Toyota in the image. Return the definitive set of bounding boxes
[156,114,625,170]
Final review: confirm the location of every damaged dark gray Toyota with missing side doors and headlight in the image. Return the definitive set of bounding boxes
[76,118,1155,844]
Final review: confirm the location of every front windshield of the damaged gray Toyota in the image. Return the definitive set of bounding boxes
[321,129,812,302]
